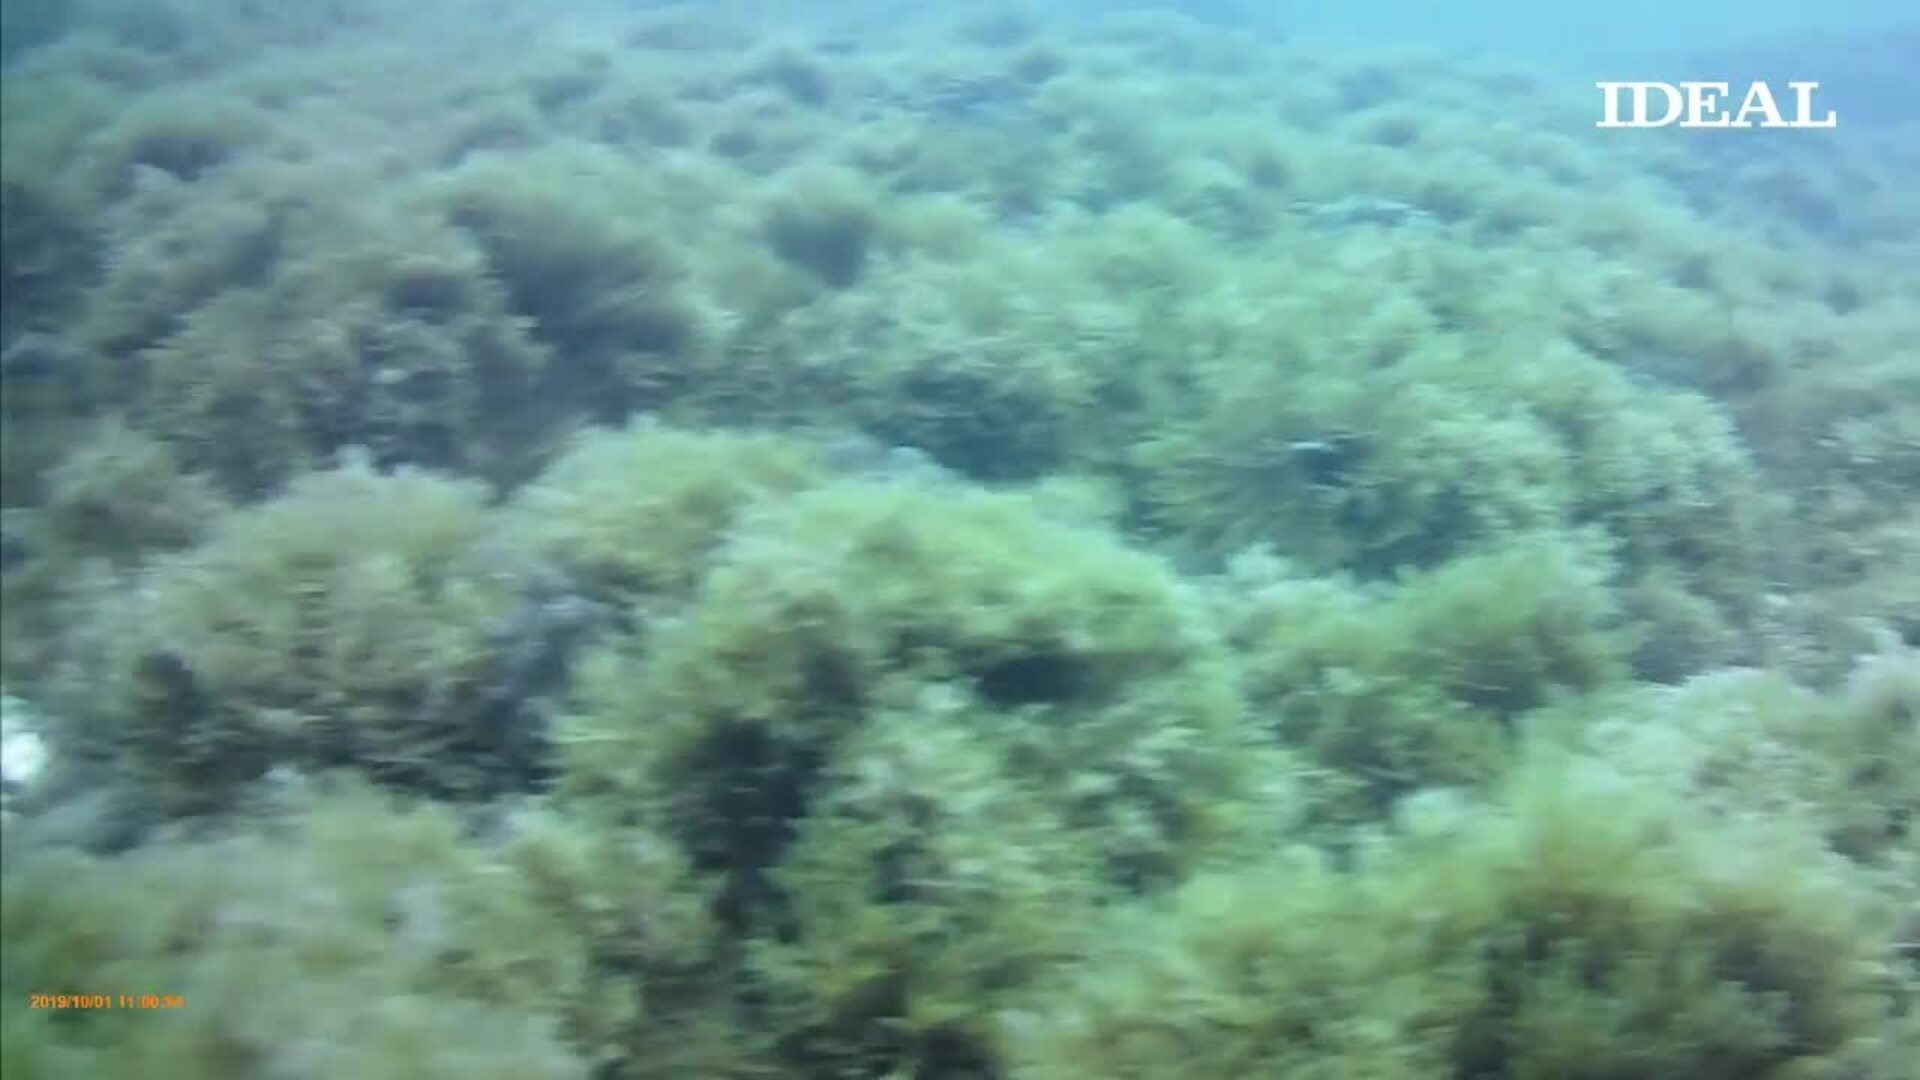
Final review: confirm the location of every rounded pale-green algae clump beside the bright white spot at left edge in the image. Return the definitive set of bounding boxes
[56,455,543,813]
